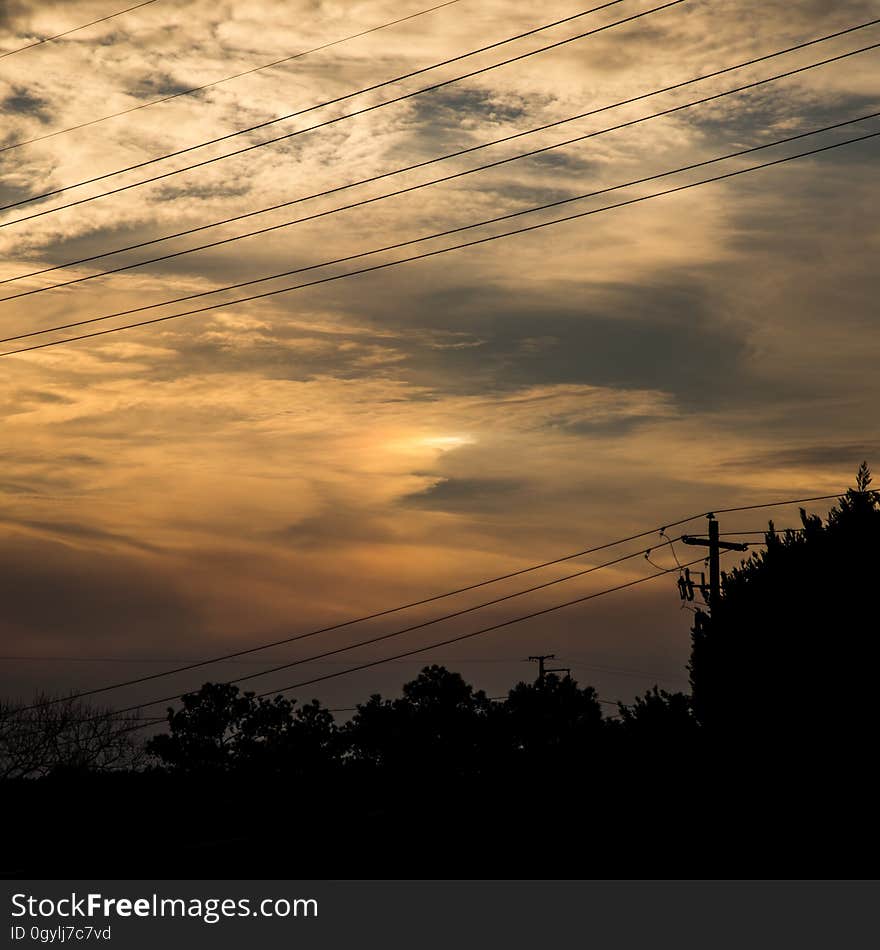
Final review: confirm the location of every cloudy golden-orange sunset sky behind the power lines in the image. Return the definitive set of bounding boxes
[0,0,880,707]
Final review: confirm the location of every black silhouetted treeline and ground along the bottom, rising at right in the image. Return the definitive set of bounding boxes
[0,466,880,878]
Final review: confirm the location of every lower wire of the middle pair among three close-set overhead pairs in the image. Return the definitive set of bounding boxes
[0,37,880,306]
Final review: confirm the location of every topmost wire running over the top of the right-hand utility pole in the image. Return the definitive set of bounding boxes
[10,493,840,711]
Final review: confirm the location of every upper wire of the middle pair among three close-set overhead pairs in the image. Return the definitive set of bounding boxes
[0,19,880,286]
